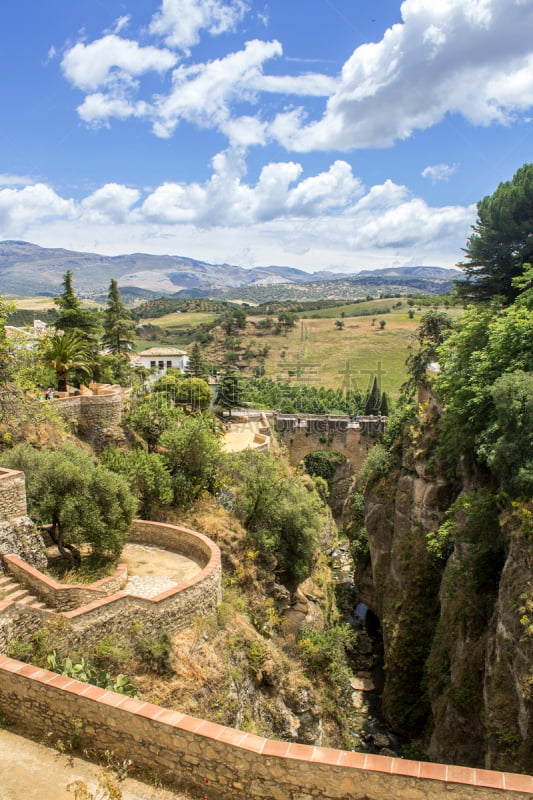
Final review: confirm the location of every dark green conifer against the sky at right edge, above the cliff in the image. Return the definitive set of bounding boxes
[455,164,533,305]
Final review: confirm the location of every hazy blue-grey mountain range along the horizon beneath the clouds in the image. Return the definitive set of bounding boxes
[0,241,461,299]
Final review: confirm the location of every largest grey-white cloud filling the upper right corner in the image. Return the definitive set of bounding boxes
[271,0,533,152]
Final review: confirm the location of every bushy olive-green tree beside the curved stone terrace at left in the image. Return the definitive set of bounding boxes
[4,444,136,564]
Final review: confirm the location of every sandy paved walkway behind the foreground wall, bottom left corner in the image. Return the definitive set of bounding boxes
[0,729,190,800]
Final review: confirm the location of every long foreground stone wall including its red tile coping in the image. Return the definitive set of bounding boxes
[0,656,533,800]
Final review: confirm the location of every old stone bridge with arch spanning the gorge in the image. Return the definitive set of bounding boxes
[273,414,386,471]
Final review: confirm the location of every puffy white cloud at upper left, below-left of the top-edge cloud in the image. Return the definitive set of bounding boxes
[61,34,178,92]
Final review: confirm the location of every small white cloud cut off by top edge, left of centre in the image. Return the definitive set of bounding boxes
[150,0,248,51]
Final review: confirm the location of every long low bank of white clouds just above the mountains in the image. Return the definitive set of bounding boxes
[0,161,476,271]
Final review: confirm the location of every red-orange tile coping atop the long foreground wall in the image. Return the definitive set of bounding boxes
[0,655,533,794]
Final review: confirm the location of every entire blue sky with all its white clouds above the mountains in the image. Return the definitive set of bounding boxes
[0,0,533,272]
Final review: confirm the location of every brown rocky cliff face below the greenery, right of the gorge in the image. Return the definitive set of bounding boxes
[356,422,533,772]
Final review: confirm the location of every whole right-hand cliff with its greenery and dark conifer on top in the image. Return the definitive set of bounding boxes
[349,165,533,772]
